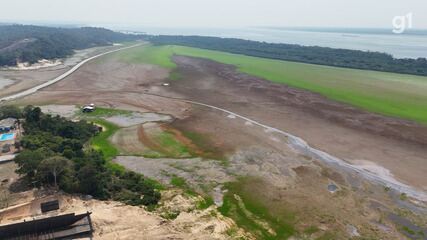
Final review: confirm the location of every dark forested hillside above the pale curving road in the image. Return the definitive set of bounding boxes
[0,25,144,66]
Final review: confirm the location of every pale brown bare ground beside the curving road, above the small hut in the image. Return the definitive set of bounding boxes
[17,56,190,118]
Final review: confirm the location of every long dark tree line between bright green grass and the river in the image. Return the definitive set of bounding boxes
[149,35,427,76]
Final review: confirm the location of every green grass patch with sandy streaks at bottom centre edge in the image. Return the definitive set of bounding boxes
[219,178,296,240]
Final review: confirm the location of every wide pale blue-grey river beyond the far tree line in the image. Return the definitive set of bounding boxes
[138,27,427,58]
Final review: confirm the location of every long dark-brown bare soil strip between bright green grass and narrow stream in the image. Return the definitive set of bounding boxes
[162,56,427,189]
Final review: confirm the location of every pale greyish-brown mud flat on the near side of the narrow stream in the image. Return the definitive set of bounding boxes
[114,108,422,239]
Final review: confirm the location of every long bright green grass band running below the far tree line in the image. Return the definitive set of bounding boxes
[121,43,427,124]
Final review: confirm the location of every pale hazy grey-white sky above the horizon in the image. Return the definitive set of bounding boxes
[0,0,427,28]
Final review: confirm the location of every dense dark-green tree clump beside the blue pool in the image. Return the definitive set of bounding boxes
[0,106,160,206]
